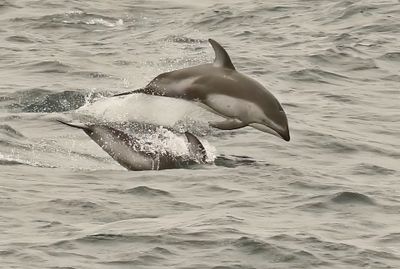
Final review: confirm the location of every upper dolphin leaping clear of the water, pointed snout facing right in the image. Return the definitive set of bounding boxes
[114,39,290,141]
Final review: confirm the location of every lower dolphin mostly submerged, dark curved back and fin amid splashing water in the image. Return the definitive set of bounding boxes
[57,120,207,171]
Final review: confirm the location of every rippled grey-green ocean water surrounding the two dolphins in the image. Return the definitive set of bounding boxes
[0,0,400,269]
